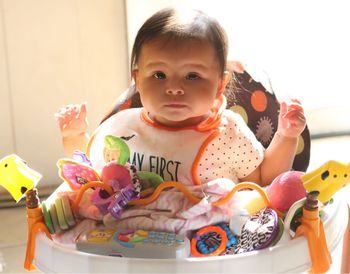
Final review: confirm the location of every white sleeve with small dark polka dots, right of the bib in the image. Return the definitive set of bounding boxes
[198,110,264,183]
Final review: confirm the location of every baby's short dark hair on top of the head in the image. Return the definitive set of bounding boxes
[131,8,228,74]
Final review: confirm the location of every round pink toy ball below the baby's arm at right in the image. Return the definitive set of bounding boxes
[266,171,306,212]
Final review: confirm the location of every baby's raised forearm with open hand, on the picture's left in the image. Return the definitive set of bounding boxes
[55,103,89,157]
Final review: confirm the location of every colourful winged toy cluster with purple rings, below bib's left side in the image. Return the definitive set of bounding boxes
[57,135,163,219]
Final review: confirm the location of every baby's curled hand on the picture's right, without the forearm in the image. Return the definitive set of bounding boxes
[277,99,306,138]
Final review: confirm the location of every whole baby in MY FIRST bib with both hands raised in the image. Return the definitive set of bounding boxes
[56,8,306,232]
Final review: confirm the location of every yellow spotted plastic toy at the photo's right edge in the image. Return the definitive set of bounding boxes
[301,160,350,204]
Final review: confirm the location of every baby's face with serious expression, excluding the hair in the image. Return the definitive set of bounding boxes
[134,39,224,127]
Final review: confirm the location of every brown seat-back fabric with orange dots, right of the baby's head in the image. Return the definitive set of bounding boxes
[225,63,311,171]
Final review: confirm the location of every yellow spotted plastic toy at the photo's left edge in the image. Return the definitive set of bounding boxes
[0,154,42,203]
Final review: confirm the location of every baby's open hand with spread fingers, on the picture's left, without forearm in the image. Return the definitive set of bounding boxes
[55,103,88,137]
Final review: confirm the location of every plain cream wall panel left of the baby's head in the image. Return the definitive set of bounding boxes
[0,0,129,191]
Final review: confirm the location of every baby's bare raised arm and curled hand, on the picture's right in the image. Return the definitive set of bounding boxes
[260,100,306,185]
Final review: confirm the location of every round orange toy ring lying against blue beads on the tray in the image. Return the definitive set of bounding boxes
[191,226,228,257]
